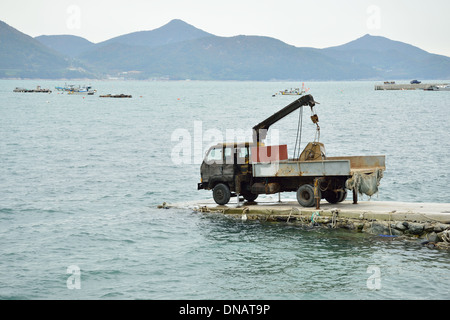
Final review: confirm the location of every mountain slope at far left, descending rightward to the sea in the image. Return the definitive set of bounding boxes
[0,21,93,78]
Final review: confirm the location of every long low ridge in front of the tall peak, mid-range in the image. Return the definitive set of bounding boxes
[80,36,371,80]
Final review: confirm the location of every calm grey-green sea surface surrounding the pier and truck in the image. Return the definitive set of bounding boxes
[0,80,450,300]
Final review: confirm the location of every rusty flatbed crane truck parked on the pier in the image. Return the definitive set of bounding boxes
[198,95,385,208]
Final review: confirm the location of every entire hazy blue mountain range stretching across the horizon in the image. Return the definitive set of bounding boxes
[0,19,450,81]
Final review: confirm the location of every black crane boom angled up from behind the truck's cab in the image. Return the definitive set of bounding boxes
[253,94,316,144]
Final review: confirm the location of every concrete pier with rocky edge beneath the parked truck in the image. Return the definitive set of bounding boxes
[164,198,450,250]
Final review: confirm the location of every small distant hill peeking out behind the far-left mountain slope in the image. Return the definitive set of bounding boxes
[35,35,95,58]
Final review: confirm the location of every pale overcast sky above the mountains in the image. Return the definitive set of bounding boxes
[0,0,450,56]
